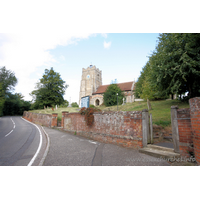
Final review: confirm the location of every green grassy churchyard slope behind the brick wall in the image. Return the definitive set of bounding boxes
[30,100,189,127]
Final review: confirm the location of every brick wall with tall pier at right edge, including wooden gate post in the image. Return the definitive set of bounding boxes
[171,97,200,165]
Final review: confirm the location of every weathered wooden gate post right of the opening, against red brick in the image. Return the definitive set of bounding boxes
[171,106,180,153]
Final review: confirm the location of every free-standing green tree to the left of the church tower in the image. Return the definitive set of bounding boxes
[31,68,68,109]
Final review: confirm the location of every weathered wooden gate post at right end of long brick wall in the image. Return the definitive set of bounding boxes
[142,109,150,147]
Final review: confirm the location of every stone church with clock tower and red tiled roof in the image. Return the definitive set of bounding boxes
[79,65,135,107]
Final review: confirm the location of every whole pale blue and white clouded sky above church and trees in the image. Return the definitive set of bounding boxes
[0,33,159,102]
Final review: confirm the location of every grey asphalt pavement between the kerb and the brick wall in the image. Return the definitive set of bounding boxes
[43,127,170,166]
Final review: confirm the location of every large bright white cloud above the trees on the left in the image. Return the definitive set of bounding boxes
[0,33,92,100]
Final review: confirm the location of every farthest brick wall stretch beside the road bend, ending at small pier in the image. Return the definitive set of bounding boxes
[23,111,57,127]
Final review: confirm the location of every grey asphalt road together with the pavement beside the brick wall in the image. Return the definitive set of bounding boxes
[0,117,169,166]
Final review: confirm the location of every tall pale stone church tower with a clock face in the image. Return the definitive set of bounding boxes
[79,65,102,105]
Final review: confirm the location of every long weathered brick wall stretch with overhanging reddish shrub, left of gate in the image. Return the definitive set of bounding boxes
[63,111,142,148]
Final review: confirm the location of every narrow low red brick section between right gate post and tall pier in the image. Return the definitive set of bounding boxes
[177,108,194,158]
